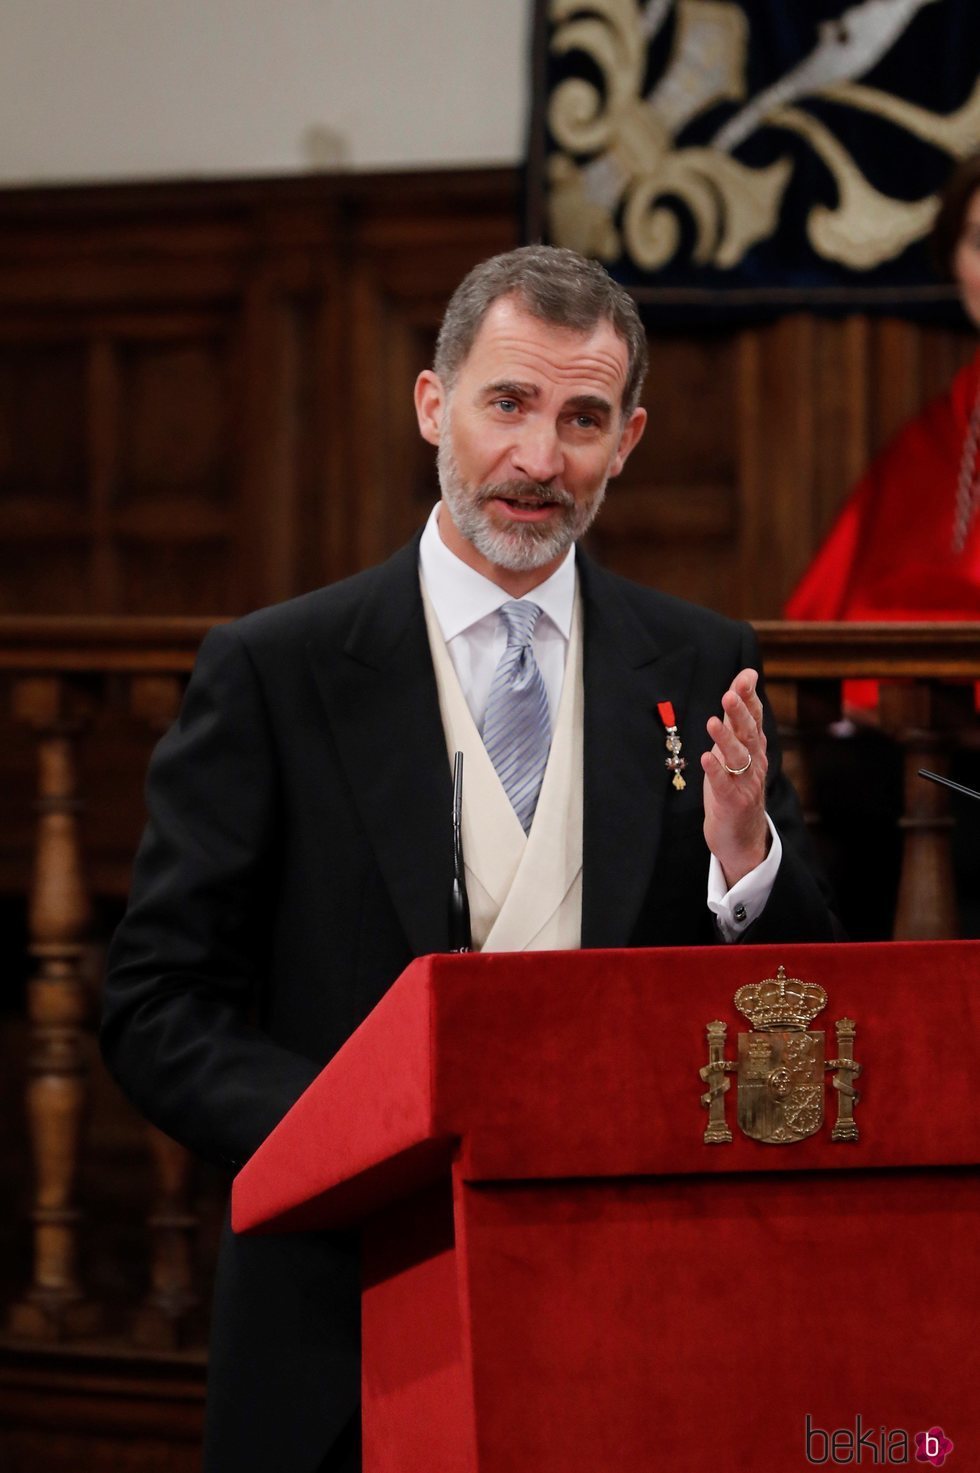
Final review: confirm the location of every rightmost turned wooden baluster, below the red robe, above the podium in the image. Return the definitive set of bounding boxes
[880,681,973,941]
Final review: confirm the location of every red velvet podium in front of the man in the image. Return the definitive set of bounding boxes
[233,941,980,1473]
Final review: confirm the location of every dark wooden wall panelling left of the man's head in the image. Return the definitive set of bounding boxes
[0,175,516,614]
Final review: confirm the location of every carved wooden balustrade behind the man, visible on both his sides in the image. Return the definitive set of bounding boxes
[0,619,980,1351]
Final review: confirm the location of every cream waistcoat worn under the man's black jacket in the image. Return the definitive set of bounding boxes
[421,585,585,952]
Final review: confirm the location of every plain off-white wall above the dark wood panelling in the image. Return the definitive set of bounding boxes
[0,0,531,184]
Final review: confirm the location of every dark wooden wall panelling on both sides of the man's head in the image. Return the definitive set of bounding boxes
[0,171,973,617]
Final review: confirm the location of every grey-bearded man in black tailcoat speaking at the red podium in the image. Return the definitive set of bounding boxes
[103,247,833,1473]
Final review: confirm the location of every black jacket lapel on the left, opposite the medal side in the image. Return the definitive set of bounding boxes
[303,538,452,956]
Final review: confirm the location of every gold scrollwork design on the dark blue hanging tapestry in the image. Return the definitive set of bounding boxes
[548,0,980,273]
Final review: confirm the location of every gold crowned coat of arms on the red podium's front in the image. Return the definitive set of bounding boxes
[700,966,861,1146]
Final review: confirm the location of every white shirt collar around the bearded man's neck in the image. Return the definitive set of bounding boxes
[419,501,575,639]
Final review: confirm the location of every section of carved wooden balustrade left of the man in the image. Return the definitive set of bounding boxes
[0,619,212,1349]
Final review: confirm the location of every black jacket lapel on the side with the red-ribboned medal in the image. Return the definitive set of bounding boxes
[578,554,700,947]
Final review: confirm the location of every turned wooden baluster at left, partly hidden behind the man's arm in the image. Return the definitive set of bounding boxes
[130,675,203,1351]
